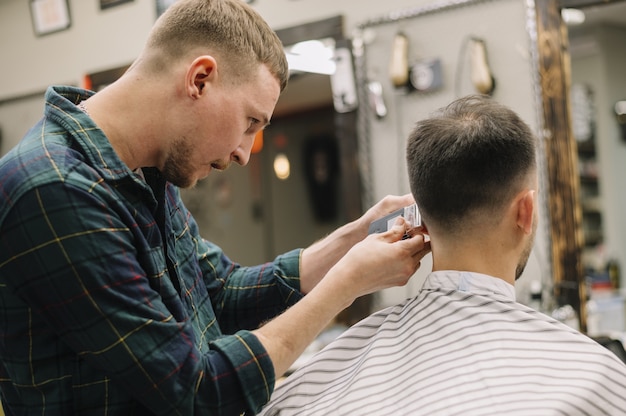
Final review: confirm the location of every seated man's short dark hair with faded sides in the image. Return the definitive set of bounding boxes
[407,95,537,232]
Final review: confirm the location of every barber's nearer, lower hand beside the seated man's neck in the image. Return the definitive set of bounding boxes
[327,218,430,303]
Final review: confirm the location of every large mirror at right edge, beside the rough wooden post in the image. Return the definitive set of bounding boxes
[561,0,626,336]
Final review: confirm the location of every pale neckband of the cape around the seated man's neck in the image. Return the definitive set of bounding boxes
[422,270,515,301]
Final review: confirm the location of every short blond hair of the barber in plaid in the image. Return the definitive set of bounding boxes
[146,0,289,91]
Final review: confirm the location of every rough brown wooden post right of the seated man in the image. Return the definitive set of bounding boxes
[535,0,586,332]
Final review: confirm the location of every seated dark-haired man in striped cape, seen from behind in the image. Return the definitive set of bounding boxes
[263,96,626,416]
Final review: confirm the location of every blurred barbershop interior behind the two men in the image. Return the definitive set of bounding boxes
[0,0,626,410]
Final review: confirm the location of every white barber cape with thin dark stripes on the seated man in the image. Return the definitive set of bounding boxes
[262,271,626,416]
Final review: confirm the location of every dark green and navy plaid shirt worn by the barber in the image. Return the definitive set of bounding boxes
[0,87,301,416]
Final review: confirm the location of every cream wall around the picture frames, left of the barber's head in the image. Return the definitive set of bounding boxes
[0,0,156,100]
